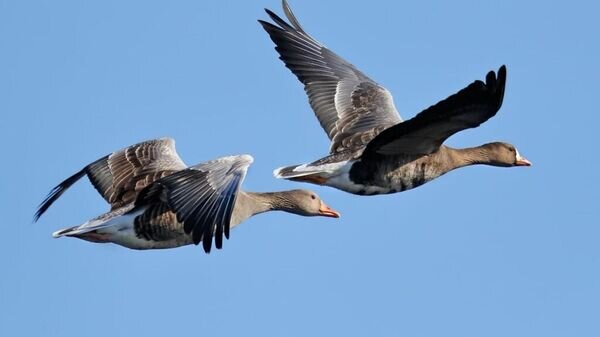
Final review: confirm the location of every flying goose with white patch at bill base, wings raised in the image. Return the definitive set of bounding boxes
[258,0,531,195]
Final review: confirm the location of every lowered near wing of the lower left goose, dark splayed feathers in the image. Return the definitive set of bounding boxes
[135,155,253,253]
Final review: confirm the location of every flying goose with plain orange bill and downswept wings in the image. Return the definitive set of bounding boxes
[34,138,340,253]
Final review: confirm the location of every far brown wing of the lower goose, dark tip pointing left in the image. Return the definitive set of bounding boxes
[34,138,186,221]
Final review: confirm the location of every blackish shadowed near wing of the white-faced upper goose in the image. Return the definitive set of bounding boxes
[363,66,506,156]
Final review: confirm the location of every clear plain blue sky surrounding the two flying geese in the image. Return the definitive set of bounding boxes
[0,0,600,337]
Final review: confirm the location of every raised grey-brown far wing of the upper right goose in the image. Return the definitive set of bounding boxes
[259,0,402,154]
